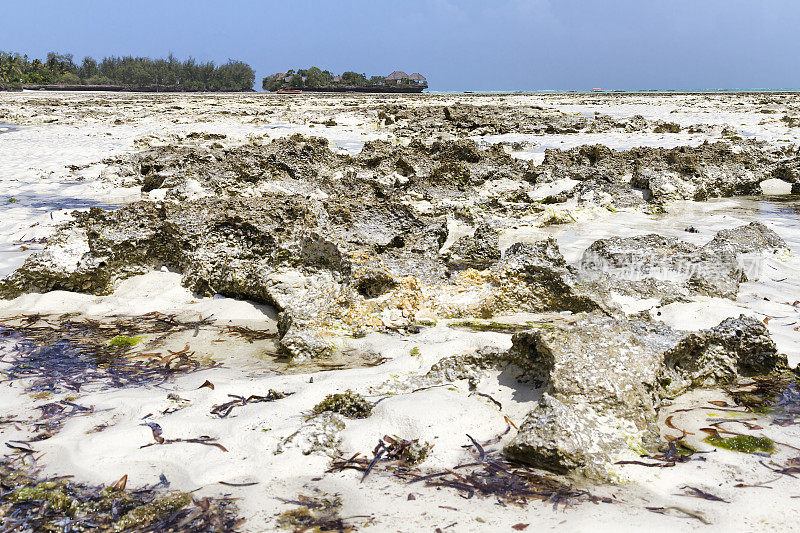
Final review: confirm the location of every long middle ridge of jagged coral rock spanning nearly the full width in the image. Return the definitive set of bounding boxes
[0,182,782,370]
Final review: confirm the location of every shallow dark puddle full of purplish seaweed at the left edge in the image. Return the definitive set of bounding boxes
[0,313,223,393]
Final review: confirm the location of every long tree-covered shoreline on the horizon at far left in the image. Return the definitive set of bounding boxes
[0,51,256,92]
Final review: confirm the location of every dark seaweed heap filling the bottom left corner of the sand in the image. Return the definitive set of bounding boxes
[0,456,244,532]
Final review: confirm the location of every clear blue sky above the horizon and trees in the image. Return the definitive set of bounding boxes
[0,0,800,91]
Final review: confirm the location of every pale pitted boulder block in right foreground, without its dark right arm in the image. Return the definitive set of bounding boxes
[506,314,661,478]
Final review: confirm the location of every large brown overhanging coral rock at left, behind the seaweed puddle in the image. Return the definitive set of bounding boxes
[0,194,446,357]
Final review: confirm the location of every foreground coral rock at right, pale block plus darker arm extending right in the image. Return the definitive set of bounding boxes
[505,313,787,479]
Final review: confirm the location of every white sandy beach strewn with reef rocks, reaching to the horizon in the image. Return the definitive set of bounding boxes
[0,91,800,532]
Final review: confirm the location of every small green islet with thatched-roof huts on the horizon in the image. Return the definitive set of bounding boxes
[261,67,428,93]
